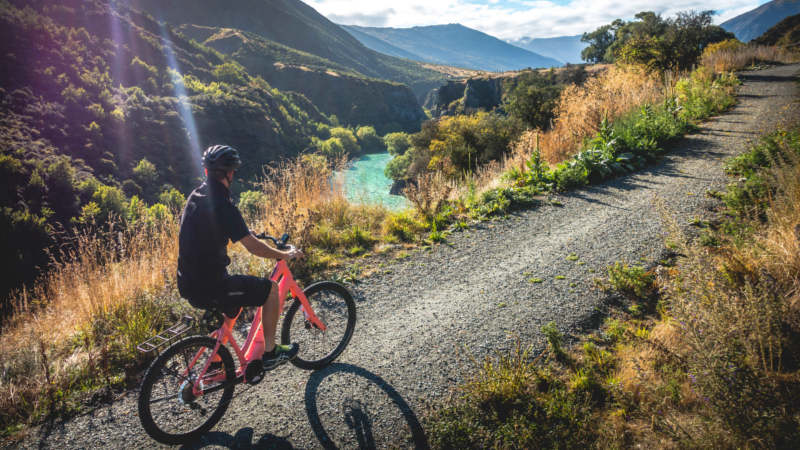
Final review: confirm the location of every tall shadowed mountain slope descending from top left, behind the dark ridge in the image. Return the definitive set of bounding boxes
[132,0,444,97]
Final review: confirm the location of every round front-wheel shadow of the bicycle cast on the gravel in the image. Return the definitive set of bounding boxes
[305,363,429,449]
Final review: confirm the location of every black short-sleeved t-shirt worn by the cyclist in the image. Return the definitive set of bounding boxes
[178,179,250,298]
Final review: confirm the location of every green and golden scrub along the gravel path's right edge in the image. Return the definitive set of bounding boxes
[426,128,800,448]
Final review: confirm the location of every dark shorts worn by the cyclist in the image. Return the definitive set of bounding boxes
[178,275,272,317]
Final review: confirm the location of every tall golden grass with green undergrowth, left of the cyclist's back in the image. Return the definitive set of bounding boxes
[0,221,177,430]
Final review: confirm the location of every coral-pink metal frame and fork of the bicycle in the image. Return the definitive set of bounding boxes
[188,260,326,396]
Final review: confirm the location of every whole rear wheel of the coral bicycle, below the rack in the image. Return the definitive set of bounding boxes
[139,336,236,444]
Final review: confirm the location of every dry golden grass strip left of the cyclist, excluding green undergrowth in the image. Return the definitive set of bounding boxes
[0,218,178,423]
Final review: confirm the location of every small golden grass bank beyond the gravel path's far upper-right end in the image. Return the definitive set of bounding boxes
[700,45,800,73]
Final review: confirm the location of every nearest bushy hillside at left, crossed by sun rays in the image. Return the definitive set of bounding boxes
[0,0,328,302]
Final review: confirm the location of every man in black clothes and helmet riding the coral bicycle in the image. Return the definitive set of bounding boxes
[178,145,303,370]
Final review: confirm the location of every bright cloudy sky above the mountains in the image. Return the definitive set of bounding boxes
[303,0,767,40]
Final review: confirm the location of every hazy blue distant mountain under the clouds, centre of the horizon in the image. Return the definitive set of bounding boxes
[343,24,562,72]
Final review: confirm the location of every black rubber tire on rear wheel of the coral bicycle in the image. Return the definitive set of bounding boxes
[138,336,236,444]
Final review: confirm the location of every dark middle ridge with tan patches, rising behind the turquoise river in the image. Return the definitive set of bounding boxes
[180,25,425,134]
